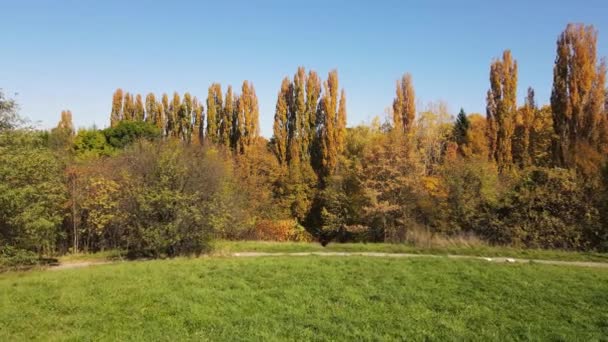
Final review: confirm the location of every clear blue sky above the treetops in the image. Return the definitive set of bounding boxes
[0,0,608,137]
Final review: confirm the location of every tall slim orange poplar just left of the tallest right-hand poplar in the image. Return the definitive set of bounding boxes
[486,50,517,171]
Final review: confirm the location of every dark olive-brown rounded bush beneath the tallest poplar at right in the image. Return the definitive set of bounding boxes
[481,168,601,249]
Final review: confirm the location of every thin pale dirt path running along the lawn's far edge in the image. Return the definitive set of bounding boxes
[48,252,608,271]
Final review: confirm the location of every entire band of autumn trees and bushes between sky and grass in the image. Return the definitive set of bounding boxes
[0,24,608,264]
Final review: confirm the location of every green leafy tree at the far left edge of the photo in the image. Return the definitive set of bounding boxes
[0,132,66,255]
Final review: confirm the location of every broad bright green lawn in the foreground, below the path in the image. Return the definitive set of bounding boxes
[0,256,608,341]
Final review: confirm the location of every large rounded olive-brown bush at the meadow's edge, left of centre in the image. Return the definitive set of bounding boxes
[118,141,248,257]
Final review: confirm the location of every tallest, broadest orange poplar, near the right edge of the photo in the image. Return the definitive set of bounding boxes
[551,24,606,172]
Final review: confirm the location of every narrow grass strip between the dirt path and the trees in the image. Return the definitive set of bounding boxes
[214,241,608,262]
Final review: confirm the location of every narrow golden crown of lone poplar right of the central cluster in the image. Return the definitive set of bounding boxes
[393,73,416,133]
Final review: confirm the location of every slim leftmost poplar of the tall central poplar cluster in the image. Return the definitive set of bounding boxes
[272,77,291,165]
